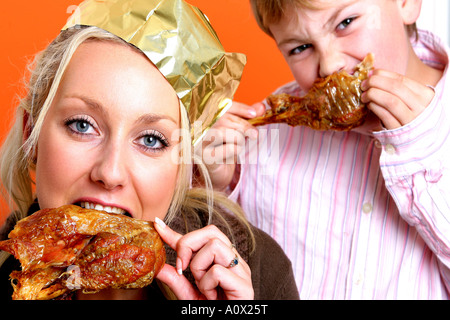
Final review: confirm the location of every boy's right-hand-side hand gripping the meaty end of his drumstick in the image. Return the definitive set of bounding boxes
[361,69,434,130]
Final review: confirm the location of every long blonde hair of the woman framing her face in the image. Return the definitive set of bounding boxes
[0,27,254,255]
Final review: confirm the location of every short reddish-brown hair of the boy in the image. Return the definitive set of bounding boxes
[250,0,418,40]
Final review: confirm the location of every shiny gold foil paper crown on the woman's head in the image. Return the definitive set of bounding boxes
[63,0,246,144]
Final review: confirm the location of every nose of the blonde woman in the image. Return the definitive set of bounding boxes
[91,141,128,190]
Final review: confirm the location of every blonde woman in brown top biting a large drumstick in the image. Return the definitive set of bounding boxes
[0,0,298,299]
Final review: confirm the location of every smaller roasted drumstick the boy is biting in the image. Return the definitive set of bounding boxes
[249,53,373,131]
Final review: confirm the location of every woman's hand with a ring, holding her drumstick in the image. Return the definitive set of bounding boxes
[155,218,254,300]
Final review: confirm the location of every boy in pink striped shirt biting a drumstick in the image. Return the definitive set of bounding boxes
[205,0,450,299]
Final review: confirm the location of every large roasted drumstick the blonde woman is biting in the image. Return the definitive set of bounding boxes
[0,205,166,300]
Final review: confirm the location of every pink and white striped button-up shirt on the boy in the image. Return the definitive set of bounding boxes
[230,31,450,299]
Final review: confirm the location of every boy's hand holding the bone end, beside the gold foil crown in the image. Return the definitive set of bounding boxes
[197,102,265,191]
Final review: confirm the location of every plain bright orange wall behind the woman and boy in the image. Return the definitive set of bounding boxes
[0,0,293,219]
